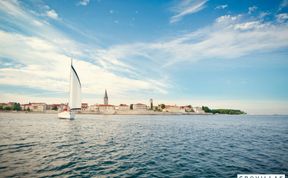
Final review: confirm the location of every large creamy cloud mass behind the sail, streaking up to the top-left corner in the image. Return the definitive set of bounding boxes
[0,1,167,103]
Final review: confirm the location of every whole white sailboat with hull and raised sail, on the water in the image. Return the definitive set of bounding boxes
[58,59,81,119]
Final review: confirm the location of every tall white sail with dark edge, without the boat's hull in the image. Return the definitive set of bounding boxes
[69,64,81,110]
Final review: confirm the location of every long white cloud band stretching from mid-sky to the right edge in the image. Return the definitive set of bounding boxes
[103,15,288,67]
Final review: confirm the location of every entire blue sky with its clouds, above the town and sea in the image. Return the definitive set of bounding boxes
[0,0,288,114]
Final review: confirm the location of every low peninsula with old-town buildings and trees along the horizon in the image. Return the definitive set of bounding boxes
[0,101,246,115]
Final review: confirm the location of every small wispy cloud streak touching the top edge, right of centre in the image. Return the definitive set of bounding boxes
[170,0,207,23]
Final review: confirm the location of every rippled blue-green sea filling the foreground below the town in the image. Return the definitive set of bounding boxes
[0,113,288,178]
